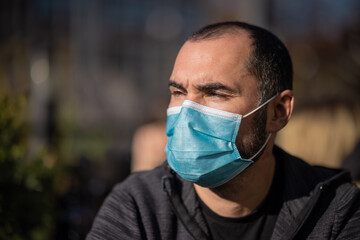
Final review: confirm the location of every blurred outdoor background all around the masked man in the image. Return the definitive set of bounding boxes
[0,0,360,240]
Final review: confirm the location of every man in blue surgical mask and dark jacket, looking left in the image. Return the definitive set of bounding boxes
[87,22,360,239]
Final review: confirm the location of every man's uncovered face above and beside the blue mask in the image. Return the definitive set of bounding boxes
[169,33,266,158]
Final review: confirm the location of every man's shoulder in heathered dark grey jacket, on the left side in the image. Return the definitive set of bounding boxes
[87,166,171,239]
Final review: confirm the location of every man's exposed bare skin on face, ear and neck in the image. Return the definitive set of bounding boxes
[169,31,293,217]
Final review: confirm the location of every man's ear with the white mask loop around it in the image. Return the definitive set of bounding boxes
[267,90,294,133]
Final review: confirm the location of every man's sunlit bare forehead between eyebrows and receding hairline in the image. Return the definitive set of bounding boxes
[171,32,252,90]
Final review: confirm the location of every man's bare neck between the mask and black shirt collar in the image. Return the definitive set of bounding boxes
[194,149,275,218]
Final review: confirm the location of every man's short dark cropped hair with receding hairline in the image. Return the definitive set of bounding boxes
[188,22,293,102]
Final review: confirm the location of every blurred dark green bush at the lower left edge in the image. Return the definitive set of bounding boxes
[0,97,63,240]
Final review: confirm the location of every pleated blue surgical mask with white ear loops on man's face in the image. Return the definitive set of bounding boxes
[165,96,276,187]
